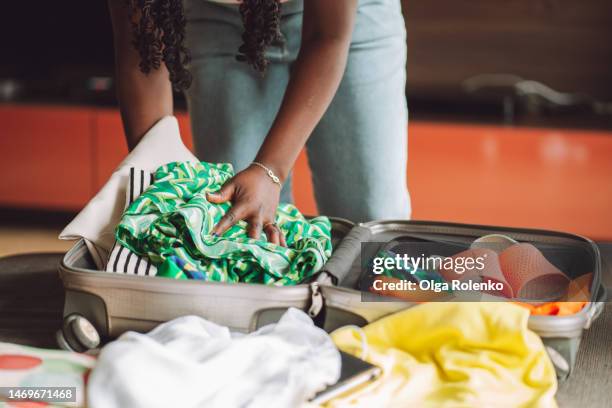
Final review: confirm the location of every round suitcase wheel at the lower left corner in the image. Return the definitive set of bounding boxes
[55,313,100,353]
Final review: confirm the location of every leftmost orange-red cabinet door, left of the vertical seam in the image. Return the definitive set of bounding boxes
[0,105,94,209]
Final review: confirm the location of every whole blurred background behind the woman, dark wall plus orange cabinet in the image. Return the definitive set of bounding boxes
[0,0,612,255]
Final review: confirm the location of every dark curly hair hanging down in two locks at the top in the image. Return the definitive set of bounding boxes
[126,0,283,90]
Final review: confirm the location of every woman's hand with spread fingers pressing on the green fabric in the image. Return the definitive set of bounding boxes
[207,165,287,246]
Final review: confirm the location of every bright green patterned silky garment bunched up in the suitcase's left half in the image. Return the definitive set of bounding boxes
[116,162,332,285]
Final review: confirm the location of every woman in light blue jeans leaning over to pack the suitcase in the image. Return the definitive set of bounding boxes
[109,0,410,244]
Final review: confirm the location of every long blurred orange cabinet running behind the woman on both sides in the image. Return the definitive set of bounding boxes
[0,105,612,240]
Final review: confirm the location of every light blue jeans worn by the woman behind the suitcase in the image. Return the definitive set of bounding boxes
[185,0,410,222]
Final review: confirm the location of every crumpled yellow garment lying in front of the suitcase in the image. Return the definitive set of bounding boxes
[327,303,557,408]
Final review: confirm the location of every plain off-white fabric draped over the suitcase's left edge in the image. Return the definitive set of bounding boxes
[59,116,197,259]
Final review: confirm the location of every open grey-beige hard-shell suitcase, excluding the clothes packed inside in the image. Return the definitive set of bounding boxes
[60,219,605,379]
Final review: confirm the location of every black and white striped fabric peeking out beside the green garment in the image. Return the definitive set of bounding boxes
[106,167,157,276]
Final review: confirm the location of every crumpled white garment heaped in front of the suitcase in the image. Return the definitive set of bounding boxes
[88,309,340,408]
